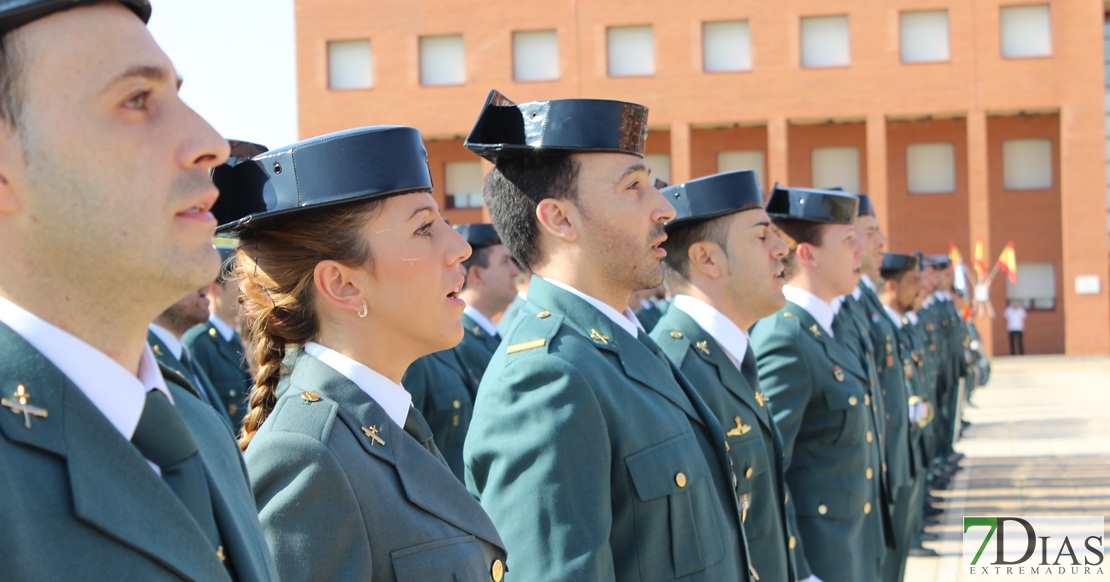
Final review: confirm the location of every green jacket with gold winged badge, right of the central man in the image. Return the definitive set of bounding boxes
[652,308,797,582]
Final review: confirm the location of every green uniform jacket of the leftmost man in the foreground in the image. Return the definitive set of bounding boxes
[0,324,278,581]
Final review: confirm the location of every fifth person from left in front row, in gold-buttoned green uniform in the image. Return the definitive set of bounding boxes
[751,188,889,582]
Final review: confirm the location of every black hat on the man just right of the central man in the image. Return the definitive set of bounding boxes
[662,170,763,231]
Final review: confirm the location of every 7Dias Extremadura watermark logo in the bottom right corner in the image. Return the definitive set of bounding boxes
[961,516,1107,579]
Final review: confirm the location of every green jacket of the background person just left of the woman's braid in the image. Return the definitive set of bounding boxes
[182,321,254,431]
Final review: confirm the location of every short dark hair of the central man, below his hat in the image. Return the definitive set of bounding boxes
[482,154,578,271]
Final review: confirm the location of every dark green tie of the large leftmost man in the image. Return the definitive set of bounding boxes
[131,390,219,548]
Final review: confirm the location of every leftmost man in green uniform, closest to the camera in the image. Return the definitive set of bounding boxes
[0,0,276,581]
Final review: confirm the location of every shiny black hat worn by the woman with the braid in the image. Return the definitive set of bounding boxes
[212,126,432,233]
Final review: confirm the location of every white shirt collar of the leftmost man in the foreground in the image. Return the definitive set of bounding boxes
[0,297,173,441]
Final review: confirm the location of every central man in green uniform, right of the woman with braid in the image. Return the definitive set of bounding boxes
[464,91,749,582]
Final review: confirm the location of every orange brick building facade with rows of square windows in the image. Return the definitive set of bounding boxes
[296,0,1110,354]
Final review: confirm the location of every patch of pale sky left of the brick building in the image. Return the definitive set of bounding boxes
[150,0,297,148]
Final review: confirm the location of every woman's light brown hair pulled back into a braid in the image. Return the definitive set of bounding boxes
[235,200,382,450]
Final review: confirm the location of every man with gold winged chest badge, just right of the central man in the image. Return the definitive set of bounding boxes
[652,170,797,581]
